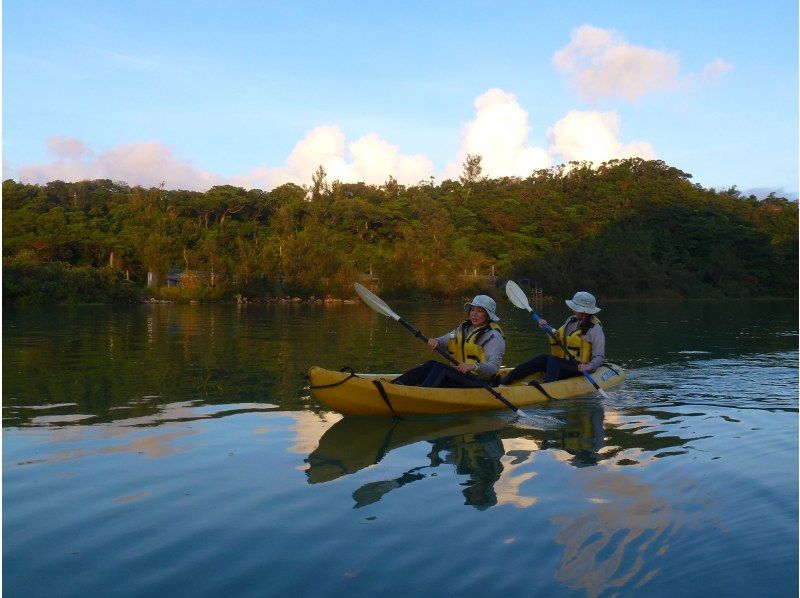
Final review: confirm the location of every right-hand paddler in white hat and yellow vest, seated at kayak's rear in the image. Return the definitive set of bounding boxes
[500,291,606,385]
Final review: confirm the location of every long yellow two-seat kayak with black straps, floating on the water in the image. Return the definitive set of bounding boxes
[308,363,627,415]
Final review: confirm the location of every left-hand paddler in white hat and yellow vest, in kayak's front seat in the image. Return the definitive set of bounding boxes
[393,295,506,388]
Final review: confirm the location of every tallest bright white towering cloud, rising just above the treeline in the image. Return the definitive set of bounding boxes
[445,89,551,178]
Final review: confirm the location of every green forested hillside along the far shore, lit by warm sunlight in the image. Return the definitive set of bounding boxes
[3,157,798,304]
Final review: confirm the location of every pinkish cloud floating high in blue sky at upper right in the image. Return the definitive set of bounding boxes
[553,25,680,101]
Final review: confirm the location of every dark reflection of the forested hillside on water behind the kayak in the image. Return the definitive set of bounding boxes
[3,301,797,426]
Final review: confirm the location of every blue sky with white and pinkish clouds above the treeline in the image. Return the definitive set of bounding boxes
[2,0,799,199]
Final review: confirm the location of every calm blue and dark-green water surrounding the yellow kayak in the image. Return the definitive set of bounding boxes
[2,301,798,597]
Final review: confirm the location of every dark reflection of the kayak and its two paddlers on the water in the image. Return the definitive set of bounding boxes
[306,400,604,509]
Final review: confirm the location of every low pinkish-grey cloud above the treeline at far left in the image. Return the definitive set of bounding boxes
[19,137,223,190]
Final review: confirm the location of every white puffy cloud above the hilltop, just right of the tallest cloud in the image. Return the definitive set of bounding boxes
[548,110,656,164]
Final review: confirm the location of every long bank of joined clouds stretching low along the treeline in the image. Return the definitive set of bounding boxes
[18,89,655,191]
